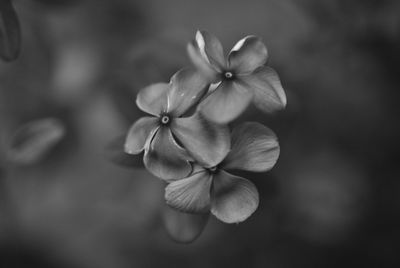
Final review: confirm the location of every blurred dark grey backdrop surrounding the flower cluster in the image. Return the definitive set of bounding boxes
[0,0,400,268]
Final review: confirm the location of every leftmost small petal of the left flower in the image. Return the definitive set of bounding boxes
[124,116,158,154]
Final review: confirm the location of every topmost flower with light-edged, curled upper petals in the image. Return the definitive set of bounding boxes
[188,31,286,123]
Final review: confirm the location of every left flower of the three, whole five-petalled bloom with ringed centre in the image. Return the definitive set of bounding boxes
[125,69,230,180]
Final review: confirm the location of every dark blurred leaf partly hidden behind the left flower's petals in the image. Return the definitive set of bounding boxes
[106,135,144,168]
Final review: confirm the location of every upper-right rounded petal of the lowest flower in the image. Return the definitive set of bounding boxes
[222,122,280,172]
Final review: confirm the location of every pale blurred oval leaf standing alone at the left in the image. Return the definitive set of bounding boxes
[7,118,65,165]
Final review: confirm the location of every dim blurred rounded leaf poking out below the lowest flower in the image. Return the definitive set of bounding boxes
[163,206,210,243]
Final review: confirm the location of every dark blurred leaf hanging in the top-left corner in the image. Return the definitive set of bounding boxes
[0,0,21,61]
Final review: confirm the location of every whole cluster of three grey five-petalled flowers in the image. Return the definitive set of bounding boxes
[125,31,286,234]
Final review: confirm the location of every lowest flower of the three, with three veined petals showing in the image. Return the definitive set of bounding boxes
[165,122,280,223]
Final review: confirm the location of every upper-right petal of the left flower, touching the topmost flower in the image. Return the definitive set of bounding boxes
[168,68,208,116]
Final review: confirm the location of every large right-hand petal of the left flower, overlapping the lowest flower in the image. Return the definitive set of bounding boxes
[171,113,230,167]
